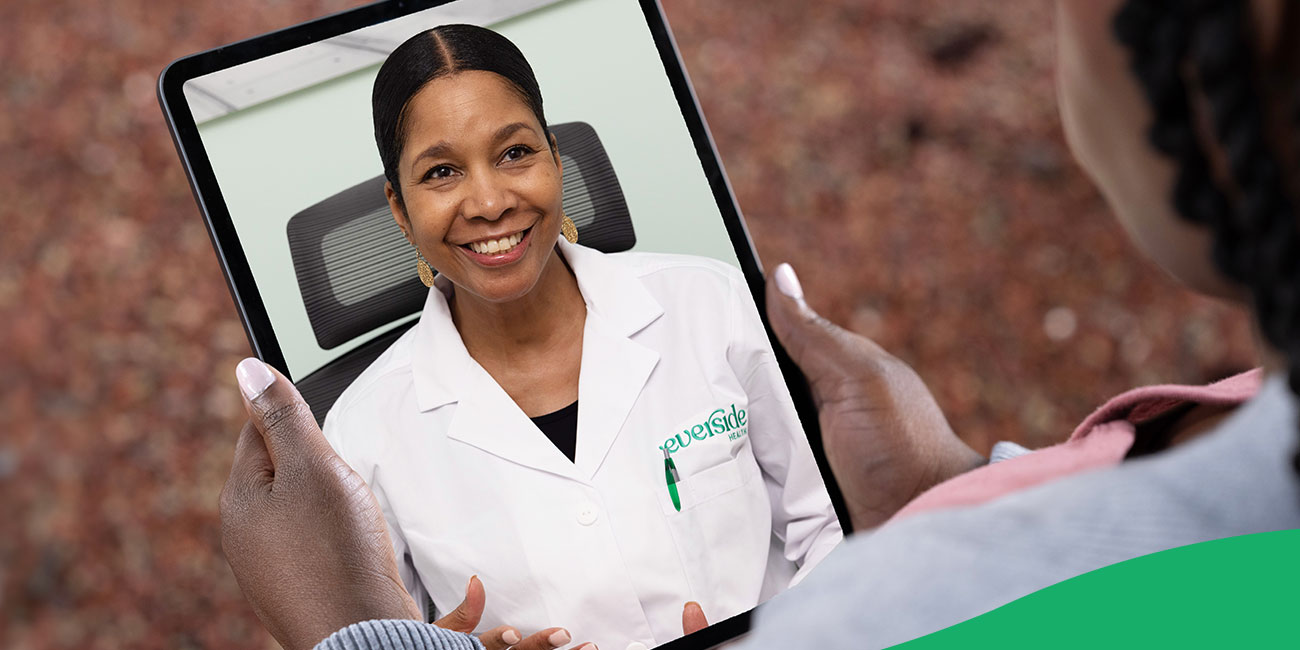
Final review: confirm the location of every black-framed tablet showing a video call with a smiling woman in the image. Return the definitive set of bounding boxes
[159,0,849,649]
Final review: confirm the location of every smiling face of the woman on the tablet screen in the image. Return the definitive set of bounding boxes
[387,70,562,303]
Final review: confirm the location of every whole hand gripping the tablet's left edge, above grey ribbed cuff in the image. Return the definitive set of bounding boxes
[221,359,420,650]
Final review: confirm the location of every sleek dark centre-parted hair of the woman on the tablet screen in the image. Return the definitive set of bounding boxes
[371,25,550,202]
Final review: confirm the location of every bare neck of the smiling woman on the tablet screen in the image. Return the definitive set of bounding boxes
[451,250,586,361]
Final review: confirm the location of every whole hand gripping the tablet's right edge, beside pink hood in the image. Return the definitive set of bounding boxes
[767,264,985,530]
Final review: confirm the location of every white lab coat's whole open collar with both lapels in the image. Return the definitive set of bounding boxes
[411,241,663,480]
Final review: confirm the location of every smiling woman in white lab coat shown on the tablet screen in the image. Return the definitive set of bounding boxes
[325,25,842,647]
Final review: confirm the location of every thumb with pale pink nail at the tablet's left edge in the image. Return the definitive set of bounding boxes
[235,358,329,467]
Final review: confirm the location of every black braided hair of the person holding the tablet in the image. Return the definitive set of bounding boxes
[1114,0,1300,472]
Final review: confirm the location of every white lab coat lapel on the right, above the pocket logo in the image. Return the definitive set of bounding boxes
[559,241,663,480]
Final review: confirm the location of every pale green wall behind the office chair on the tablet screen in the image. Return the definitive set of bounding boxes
[199,0,737,377]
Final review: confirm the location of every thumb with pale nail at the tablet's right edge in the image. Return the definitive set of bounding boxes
[767,264,883,387]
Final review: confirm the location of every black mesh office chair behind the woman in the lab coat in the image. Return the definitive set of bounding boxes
[287,122,636,423]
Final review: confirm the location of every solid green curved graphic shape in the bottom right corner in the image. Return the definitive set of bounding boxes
[894,530,1300,650]
